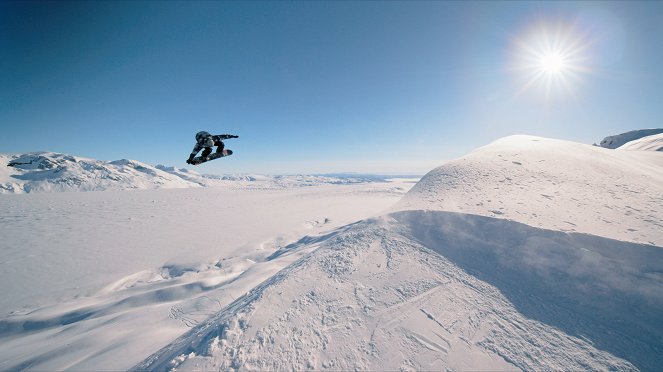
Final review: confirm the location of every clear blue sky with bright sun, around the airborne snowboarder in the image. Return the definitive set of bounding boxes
[0,1,663,174]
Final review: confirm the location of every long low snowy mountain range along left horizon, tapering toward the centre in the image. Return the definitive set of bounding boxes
[0,152,392,194]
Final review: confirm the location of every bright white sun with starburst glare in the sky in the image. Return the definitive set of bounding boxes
[514,22,589,100]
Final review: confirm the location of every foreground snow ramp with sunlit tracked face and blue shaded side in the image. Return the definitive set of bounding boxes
[135,211,663,371]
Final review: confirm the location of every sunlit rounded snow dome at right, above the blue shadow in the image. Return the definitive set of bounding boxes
[395,136,663,246]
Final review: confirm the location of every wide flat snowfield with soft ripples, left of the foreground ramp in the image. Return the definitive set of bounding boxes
[0,180,415,370]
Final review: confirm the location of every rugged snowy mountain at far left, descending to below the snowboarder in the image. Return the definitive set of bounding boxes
[0,152,198,194]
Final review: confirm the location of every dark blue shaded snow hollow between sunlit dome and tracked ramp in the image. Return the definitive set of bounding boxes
[390,211,663,370]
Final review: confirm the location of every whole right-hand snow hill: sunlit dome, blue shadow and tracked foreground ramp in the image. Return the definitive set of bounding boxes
[134,136,663,370]
